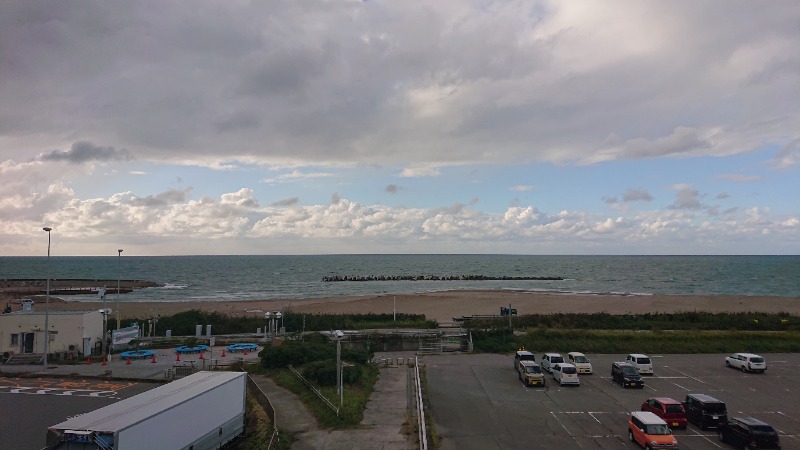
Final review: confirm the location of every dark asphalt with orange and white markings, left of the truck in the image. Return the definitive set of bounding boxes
[0,378,158,450]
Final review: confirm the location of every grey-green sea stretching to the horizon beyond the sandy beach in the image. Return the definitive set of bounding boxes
[0,254,800,302]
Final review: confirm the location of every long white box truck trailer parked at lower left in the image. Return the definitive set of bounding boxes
[46,372,247,450]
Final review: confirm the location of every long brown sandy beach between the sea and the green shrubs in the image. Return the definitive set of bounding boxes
[36,291,800,323]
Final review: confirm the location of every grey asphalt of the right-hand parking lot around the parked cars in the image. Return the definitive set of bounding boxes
[424,351,800,450]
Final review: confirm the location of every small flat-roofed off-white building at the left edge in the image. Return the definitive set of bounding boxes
[0,309,103,355]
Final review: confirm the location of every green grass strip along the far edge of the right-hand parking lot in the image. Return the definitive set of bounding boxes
[473,328,800,353]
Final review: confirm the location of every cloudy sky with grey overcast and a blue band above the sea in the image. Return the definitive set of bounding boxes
[0,0,800,256]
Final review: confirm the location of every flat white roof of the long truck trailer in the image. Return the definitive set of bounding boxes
[49,372,247,433]
